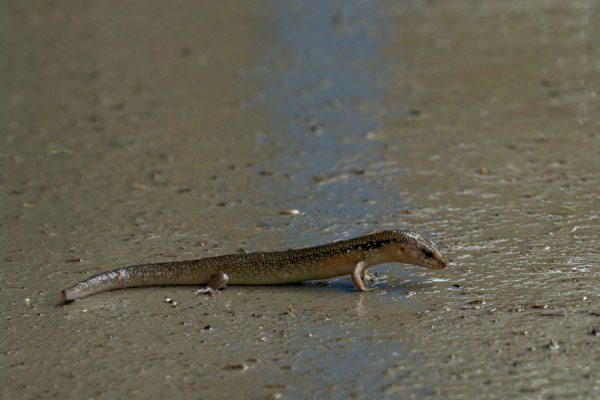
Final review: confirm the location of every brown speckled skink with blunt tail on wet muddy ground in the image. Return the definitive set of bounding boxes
[62,230,446,301]
